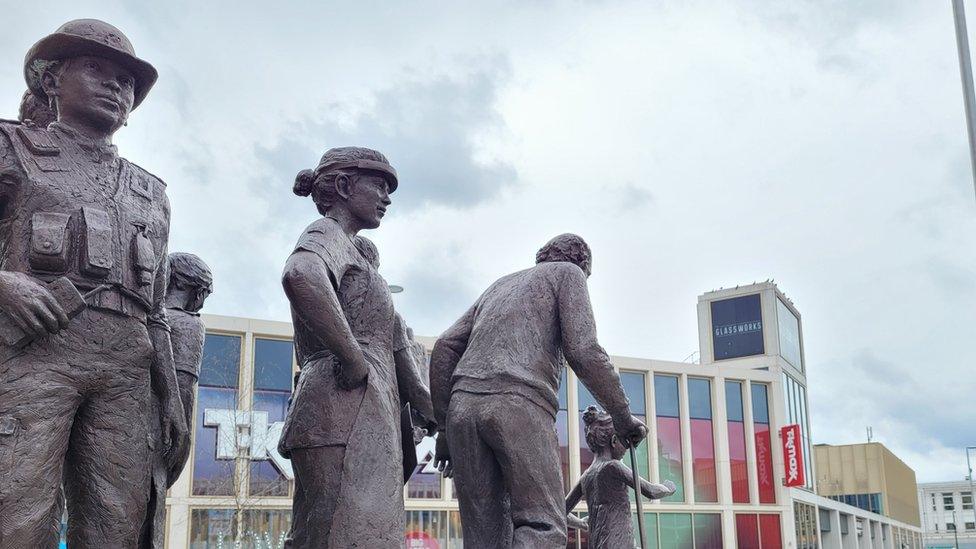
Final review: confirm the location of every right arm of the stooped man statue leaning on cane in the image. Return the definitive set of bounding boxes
[558,263,630,419]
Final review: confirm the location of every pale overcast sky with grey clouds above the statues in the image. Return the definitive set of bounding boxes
[0,0,976,481]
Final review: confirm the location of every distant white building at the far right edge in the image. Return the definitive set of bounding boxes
[918,480,976,549]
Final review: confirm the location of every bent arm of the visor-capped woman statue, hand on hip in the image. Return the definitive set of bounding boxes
[281,249,369,389]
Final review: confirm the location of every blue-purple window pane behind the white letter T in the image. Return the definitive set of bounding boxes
[193,386,237,496]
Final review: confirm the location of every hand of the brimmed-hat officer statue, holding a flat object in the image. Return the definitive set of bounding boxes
[0,271,69,338]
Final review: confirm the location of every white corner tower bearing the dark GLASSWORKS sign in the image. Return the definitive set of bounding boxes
[698,282,816,491]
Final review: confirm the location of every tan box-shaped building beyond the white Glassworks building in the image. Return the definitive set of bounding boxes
[813,442,921,526]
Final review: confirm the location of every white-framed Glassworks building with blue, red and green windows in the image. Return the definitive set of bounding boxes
[166,284,921,549]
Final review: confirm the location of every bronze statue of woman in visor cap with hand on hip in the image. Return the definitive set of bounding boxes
[278,147,428,549]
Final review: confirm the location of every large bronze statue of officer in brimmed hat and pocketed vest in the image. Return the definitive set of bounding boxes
[0,19,188,549]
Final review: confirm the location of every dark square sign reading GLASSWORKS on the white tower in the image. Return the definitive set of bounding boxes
[711,294,765,360]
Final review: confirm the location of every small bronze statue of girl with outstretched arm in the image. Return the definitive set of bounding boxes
[566,406,675,549]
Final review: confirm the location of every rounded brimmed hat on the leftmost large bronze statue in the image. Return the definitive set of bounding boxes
[24,19,157,109]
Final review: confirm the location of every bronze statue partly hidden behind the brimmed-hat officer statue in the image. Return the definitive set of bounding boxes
[142,252,213,549]
